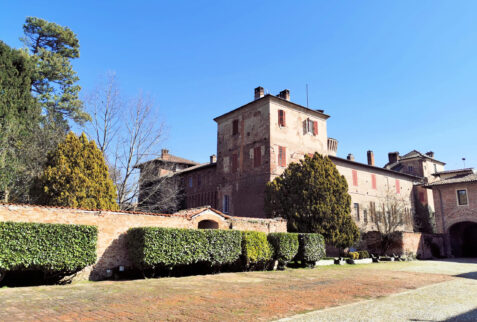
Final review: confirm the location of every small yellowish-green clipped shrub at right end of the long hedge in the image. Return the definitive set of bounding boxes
[242,231,273,266]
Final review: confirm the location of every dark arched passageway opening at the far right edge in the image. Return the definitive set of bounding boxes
[449,221,477,257]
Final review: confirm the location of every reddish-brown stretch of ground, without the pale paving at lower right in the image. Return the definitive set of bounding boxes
[0,262,453,321]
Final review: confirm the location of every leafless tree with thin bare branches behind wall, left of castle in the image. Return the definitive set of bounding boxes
[86,74,180,212]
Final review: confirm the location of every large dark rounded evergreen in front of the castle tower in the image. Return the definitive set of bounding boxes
[265,153,359,248]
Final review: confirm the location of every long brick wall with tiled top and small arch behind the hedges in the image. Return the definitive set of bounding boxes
[0,205,287,280]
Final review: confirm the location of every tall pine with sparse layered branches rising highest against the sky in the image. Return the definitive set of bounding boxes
[22,17,90,130]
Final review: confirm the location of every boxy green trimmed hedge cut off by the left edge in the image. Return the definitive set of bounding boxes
[0,222,98,273]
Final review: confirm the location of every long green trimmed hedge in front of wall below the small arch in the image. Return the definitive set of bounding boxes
[127,227,241,269]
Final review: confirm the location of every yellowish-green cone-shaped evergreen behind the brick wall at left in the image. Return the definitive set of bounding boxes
[36,132,118,210]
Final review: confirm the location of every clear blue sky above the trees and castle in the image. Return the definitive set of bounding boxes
[0,0,477,169]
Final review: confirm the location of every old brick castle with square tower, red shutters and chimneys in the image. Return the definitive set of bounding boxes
[137,87,436,231]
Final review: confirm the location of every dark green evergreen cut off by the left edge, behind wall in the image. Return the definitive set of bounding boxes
[0,41,40,202]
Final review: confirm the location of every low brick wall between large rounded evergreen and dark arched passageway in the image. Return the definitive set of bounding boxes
[364,232,445,259]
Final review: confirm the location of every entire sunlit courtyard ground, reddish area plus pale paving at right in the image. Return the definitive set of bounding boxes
[0,261,477,321]
